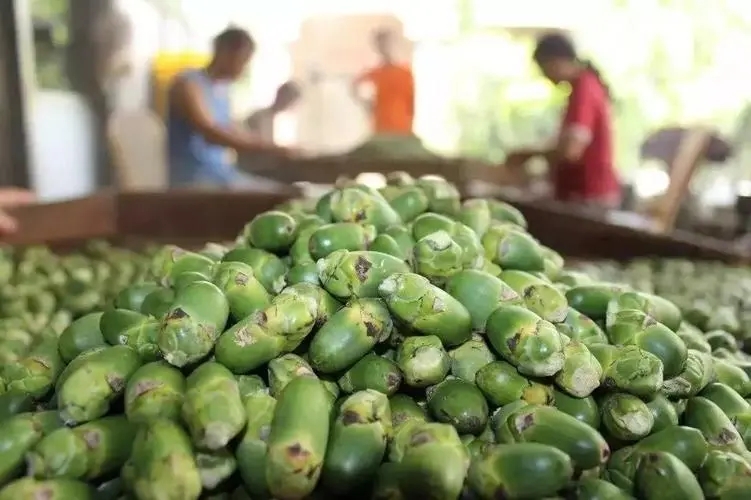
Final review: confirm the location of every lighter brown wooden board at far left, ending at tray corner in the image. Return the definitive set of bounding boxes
[2,193,117,245]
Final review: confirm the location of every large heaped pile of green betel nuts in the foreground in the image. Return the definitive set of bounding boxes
[0,174,751,500]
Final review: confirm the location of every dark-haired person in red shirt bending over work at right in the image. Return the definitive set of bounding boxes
[506,33,621,207]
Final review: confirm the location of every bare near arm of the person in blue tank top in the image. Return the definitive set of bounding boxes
[170,80,286,151]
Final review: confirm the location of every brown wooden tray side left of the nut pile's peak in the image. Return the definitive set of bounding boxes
[2,189,298,247]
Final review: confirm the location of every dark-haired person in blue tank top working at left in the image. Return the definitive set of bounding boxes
[167,28,289,189]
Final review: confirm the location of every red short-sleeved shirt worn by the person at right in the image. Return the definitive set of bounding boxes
[552,71,620,201]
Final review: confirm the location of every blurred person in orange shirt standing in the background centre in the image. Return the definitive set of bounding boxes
[352,29,415,135]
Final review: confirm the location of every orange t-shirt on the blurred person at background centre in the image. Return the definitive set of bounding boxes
[358,64,415,134]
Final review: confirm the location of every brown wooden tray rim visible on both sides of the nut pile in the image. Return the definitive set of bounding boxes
[4,190,749,264]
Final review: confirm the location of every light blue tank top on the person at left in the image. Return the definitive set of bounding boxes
[167,70,238,186]
